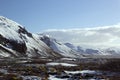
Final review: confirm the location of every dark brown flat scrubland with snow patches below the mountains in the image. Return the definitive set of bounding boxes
[0,57,120,80]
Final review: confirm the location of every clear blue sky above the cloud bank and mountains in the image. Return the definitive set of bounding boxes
[0,0,120,33]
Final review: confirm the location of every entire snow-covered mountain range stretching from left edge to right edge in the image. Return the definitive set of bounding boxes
[0,16,120,58]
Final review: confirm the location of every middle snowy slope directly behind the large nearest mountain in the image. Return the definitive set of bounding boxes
[39,34,82,58]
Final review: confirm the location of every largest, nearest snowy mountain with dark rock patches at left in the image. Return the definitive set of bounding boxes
[0,16,60,57]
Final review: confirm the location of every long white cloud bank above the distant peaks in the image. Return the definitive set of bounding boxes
[44,24,120,48]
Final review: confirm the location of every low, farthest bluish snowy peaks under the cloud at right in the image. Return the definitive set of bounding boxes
[65,43,120,55]
